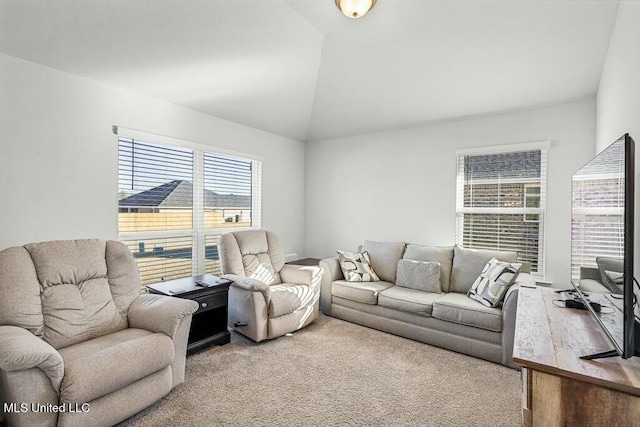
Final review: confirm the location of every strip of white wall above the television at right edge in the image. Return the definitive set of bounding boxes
[596,1,640,152]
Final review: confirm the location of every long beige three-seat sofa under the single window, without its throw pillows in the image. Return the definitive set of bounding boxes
[320,241,535,367]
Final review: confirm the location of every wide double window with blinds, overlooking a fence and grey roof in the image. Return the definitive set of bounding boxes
[118,130,261,285]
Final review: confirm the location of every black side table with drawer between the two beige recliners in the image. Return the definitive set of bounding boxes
[147,274,232,354]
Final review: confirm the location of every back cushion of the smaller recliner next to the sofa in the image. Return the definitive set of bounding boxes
[218,230,284,285]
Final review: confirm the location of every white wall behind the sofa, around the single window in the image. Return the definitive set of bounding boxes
[305,99,595,287]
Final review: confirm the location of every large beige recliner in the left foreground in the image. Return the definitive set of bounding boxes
[0,240,198,426]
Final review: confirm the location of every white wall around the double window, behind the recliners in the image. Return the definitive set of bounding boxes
[0,51,305,254]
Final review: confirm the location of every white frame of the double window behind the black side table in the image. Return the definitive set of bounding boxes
[112,126,263,286]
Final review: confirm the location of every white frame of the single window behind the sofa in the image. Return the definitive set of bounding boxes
[455,141,551,279]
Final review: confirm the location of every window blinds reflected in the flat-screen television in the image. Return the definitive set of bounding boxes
[571,144,625,279]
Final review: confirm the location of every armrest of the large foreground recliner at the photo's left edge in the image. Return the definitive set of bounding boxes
[0,326,64,392]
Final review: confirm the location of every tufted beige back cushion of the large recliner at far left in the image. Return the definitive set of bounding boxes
[0,239,140,349]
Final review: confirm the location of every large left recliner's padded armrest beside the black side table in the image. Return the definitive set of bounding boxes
[128,294,198,339]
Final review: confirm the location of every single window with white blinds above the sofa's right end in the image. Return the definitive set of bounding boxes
[456,143,548,276]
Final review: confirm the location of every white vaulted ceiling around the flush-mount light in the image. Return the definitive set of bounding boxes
[0,0,619,141]
